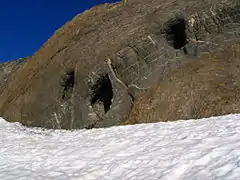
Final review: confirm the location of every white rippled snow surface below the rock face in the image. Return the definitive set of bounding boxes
[0,114,240,180]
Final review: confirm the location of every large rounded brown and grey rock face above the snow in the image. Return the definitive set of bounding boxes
[0,0,240,129]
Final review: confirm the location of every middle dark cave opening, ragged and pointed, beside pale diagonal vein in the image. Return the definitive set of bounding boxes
[90,74,113,113]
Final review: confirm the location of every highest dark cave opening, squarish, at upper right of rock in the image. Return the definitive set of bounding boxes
[166,19,188,49]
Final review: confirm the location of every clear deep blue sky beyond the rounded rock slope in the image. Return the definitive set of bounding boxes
[0,0,119,62]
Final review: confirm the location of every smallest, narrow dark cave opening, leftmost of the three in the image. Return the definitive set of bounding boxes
[61,70,75,99]
